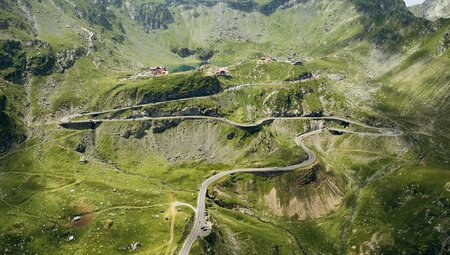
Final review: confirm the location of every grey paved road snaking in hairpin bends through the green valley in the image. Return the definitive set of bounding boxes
[60,103,402,255]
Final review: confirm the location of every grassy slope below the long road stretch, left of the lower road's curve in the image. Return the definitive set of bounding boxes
[0,117,312,254]
